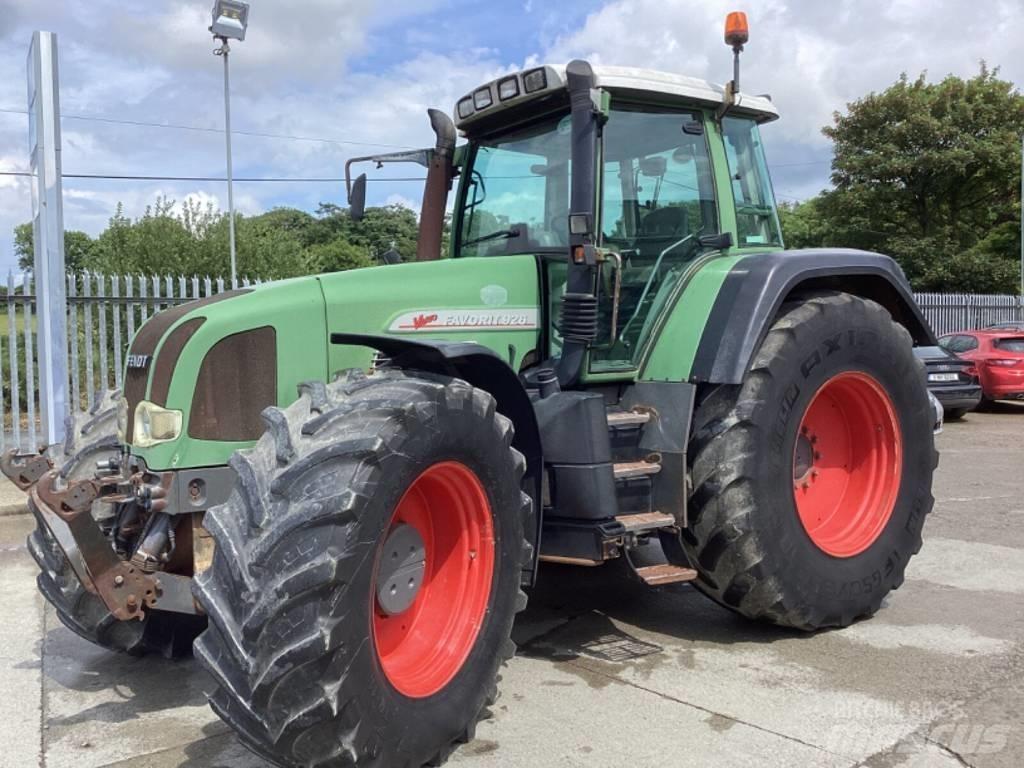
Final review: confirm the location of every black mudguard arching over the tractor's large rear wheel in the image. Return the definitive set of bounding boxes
[689,248,936,384]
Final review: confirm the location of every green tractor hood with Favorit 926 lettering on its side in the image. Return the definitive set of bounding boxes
[133,256,541,470]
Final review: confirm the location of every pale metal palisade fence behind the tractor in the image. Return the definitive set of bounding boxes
[0,273,1024,451]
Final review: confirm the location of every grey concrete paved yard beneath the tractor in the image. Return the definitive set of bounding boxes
[0,406,1024,768]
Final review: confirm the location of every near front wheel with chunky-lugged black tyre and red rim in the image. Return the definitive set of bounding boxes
[195,371,531,768]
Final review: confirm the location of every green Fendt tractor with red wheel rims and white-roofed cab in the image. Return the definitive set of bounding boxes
[2,16,936,768]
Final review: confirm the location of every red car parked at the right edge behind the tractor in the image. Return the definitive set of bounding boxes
[939,329,1024,400]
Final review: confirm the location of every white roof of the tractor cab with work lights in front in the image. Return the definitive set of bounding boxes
[455,65,778,128]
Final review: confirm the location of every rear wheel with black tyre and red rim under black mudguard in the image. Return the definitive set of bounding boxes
[682,293,937,630]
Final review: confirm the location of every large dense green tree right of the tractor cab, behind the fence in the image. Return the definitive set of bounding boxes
[823,63,1024,292]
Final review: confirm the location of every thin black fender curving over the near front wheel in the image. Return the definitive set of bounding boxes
[331,333,544,585]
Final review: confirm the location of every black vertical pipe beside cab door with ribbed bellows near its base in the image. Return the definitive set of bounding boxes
[555,59,601,388]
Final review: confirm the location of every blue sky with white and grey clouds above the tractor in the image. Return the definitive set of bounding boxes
[0,0,1024,271]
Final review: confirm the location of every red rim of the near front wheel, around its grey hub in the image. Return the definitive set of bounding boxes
[372,462,495,698]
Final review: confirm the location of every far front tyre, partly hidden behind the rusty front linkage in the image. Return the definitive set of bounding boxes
[28,389,206,658]
